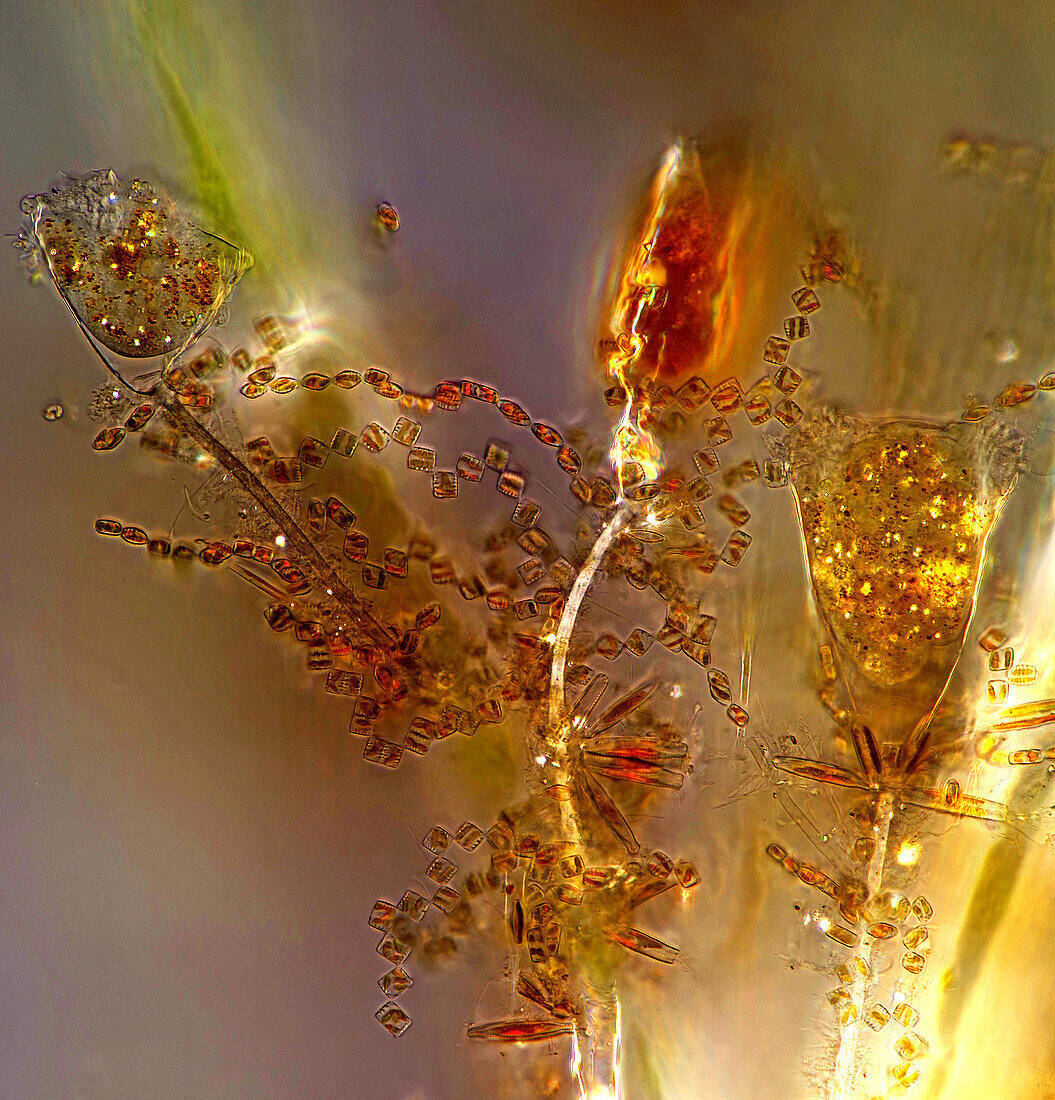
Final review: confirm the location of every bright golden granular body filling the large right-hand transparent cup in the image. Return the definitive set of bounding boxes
[792,416,1010,685]
